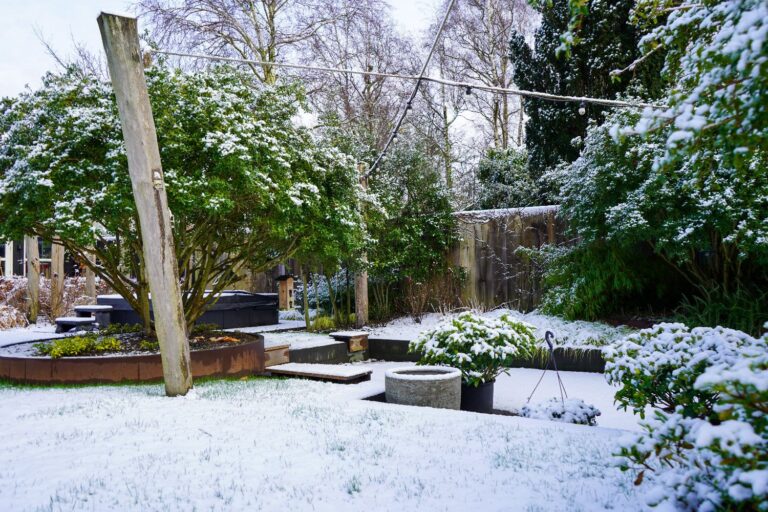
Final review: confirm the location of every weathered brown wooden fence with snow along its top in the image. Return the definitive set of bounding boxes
[451,206,566,311]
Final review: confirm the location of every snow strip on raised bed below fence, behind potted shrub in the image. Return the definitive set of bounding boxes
[371,309,633,346]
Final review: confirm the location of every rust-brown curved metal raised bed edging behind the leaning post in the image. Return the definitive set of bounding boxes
[0,332,265,384]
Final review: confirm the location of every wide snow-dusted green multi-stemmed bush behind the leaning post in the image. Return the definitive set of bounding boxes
[0,63,361,325]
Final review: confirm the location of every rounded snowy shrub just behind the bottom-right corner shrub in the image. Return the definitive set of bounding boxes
[604,323,764,418]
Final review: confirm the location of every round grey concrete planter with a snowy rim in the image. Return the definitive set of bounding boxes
[384,366,461,409]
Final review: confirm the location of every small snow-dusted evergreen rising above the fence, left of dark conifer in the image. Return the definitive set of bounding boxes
[477,148,538,209]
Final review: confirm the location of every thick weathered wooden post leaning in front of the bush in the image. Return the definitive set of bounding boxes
[98,13,192,396]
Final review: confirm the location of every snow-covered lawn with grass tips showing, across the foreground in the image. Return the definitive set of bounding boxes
[0,372,643,511]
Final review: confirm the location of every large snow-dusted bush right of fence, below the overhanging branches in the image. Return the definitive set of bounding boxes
[545,101,768,324]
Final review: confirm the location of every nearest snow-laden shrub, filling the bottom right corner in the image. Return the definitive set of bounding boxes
[618,336,768,511]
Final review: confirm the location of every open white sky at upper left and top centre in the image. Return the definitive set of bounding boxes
[0,0,440,97]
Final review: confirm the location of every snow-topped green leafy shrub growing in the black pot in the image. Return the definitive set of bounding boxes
[410,312,536,387]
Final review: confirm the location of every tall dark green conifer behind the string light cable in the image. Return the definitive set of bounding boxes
[510,0,661,202]
